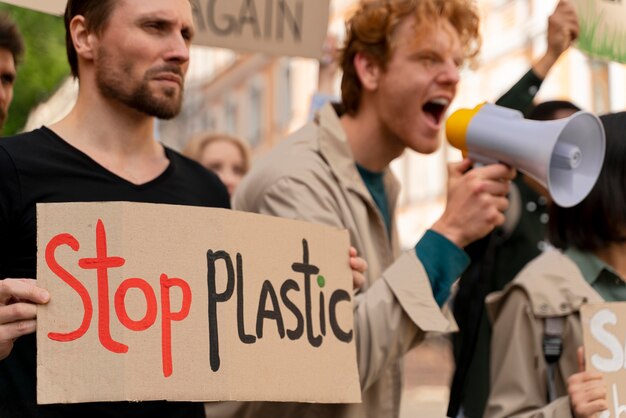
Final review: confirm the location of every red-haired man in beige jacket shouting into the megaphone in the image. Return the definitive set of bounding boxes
[233,0,514,418]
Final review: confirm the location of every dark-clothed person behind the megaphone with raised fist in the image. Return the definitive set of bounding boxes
[447,0,579,418]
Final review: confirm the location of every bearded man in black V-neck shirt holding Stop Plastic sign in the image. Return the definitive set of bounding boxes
[0,0,229,418]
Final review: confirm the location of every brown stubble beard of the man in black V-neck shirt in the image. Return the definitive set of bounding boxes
[96,49,183,120]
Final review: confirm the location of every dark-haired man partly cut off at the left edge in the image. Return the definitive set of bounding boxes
[0,13,24,132]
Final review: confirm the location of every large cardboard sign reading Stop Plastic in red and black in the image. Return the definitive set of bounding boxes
[37,202,360,404]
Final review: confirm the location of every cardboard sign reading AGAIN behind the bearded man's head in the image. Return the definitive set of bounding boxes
[5,0,330,58]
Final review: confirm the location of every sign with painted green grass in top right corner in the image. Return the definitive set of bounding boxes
[574,0,626,63]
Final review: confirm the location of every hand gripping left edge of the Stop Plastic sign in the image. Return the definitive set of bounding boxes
[0,279,50,360]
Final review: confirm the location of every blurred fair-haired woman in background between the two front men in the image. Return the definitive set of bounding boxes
[183,133,250,196]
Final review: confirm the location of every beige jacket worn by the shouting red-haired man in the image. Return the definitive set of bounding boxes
[208,105,454,418]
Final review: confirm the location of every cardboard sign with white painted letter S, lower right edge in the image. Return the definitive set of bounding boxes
[580,302,626,418]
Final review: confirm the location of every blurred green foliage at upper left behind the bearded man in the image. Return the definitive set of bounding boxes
[0,3,70,135]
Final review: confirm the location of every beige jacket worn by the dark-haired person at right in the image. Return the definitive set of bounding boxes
[485,250,602,418]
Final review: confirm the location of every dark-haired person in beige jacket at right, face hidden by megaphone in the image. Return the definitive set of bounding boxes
[485,112,626,418]
